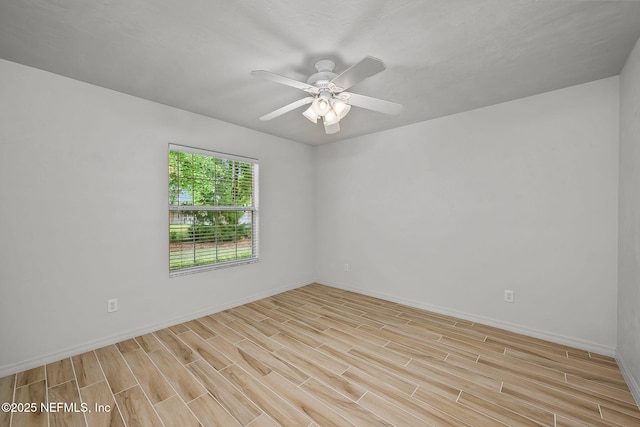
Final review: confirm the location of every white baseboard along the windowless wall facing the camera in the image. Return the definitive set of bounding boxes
[317,280,616,357]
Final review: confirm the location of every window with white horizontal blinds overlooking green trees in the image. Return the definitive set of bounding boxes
[169,144,258,276]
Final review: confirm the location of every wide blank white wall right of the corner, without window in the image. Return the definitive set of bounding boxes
[316,77,618,355]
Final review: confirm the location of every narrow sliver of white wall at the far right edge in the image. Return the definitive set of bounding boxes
[617,36,640,405]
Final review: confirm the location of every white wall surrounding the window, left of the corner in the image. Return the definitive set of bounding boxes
[0,61,314,377]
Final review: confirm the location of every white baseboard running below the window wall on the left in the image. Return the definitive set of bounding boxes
[0,281,313,378]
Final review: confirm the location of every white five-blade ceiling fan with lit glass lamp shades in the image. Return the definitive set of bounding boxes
[251,56,402,134]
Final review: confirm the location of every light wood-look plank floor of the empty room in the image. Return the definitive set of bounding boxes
[0,284,640,427]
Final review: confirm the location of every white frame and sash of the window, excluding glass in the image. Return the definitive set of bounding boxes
[166,143,260,277]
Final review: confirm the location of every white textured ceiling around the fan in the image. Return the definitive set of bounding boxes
[0,0,640,144]
